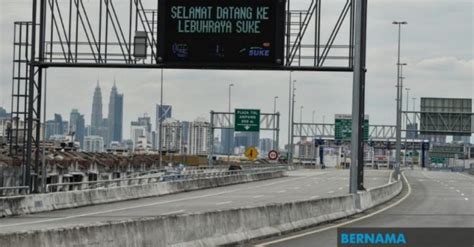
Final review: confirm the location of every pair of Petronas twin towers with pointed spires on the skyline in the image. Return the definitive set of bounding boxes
[91,81,123,147]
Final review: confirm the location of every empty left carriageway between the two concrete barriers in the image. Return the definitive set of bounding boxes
[0,169,390,233]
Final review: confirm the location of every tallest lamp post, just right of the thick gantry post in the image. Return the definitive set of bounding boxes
[392,21,408,177]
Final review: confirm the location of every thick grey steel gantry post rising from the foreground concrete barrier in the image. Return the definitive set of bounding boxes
[349,0,367,194]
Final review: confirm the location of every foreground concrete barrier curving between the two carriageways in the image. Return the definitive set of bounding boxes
[0,173,403,247]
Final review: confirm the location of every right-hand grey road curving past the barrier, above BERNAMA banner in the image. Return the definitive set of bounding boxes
[258,170,474,247]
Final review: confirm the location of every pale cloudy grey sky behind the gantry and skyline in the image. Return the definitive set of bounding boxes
[0,0,474,144]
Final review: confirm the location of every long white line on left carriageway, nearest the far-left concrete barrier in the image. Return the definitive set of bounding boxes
[0,172,332,228]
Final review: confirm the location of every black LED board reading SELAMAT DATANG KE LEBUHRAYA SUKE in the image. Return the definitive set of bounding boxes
[158,0,285,67]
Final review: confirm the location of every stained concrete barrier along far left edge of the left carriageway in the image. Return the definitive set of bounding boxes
[0,171,284,216]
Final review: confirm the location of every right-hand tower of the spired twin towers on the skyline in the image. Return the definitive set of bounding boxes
[107,82,123,145]
